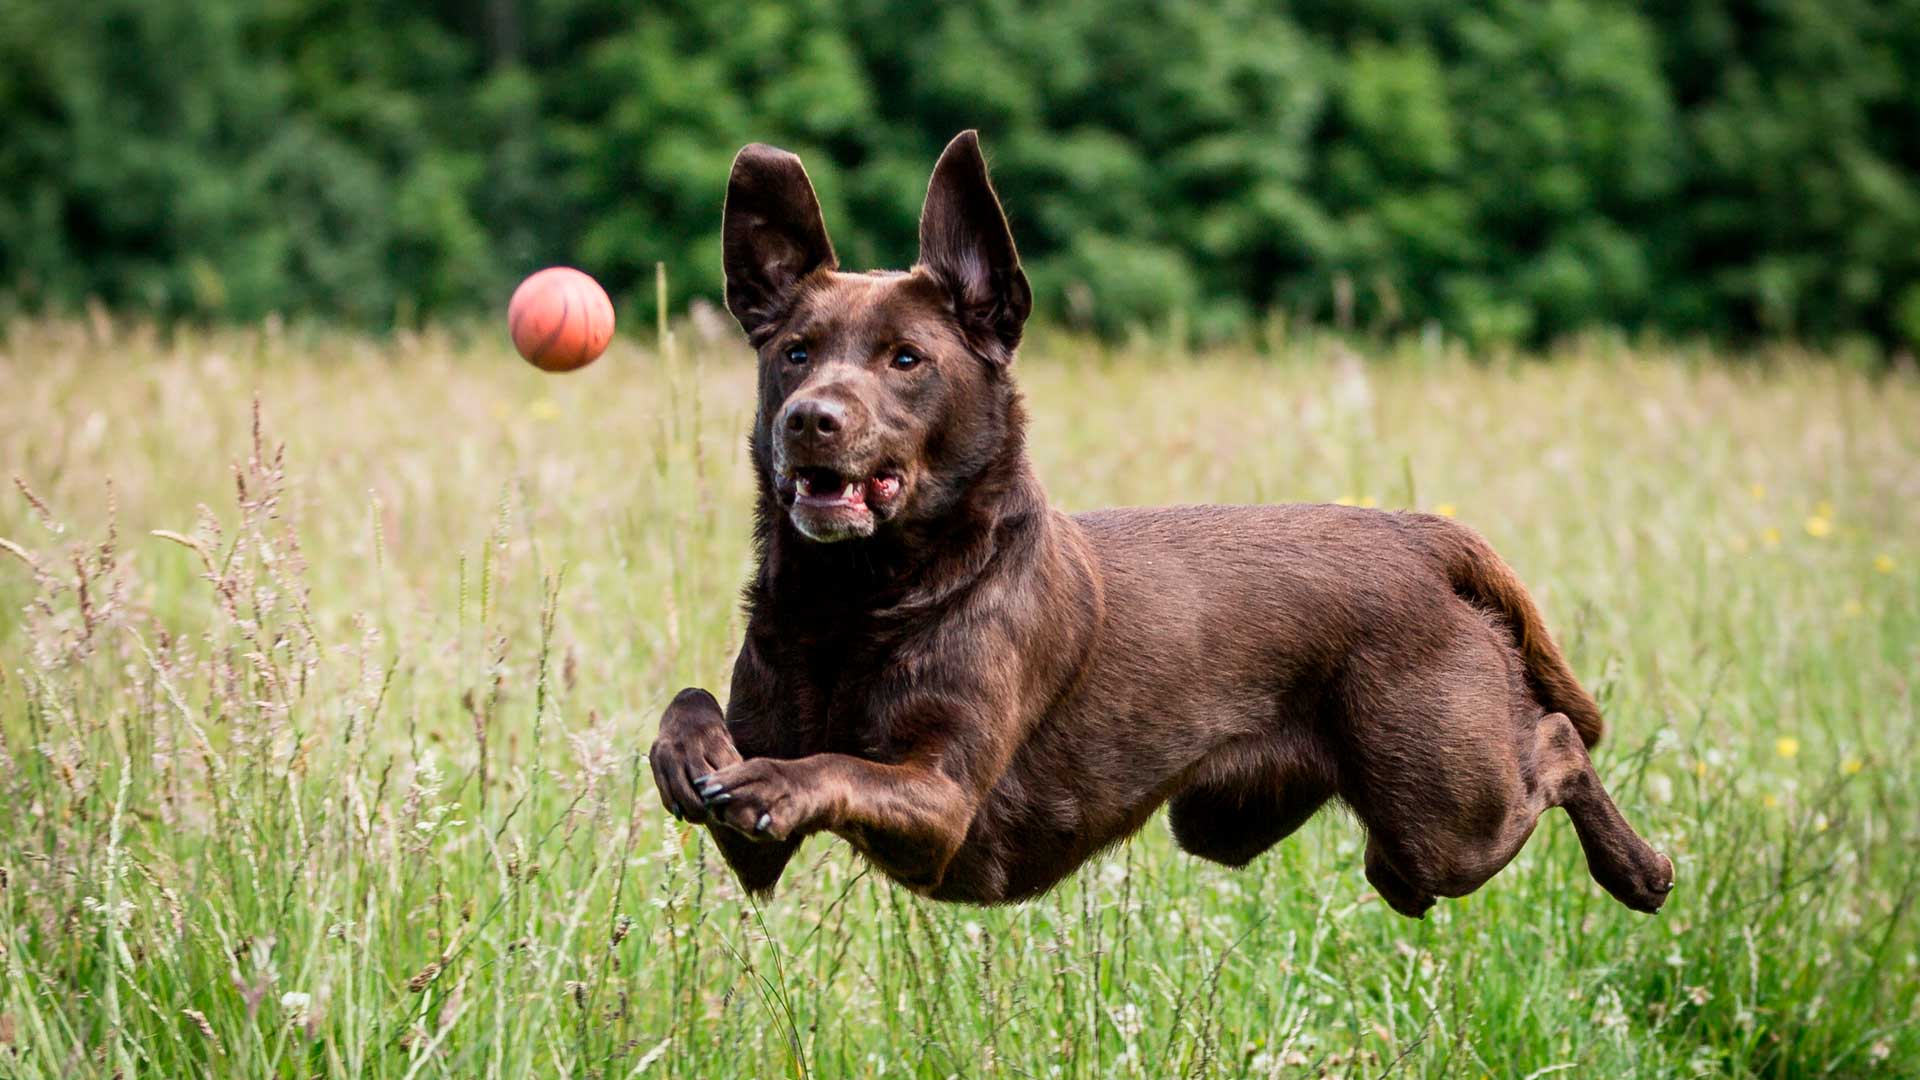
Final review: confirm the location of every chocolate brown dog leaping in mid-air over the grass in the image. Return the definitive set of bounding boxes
[651,133,1672,917]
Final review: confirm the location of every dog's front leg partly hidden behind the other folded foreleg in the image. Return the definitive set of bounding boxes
[647,688,801,894]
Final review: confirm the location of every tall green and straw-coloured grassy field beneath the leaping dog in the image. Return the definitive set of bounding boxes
[0,321,1920,1078]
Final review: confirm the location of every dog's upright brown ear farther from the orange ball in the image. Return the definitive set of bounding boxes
[920,131,1033,357]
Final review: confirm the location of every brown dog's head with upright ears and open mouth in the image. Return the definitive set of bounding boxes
[722,131,1033,542]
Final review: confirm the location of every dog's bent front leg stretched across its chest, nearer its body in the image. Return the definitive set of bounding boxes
[699,753,977,888]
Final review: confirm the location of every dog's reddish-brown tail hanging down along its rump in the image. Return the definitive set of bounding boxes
[1405,513,1607,746]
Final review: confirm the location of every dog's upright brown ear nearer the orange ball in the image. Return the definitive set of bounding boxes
[720,142,837,336]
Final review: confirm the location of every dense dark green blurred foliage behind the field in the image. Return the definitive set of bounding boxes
[0,0,1920,344]
